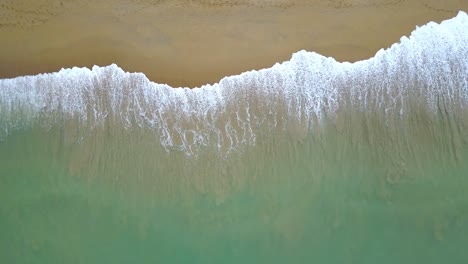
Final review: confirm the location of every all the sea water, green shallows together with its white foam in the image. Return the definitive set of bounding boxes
[0,12,468,264]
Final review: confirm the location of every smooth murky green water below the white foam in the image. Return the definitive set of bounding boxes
[0,112,468,263]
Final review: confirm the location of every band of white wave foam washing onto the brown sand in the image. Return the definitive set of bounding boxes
[0,12,468,155]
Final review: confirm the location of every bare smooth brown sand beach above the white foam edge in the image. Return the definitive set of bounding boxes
[0,0,468,87]
